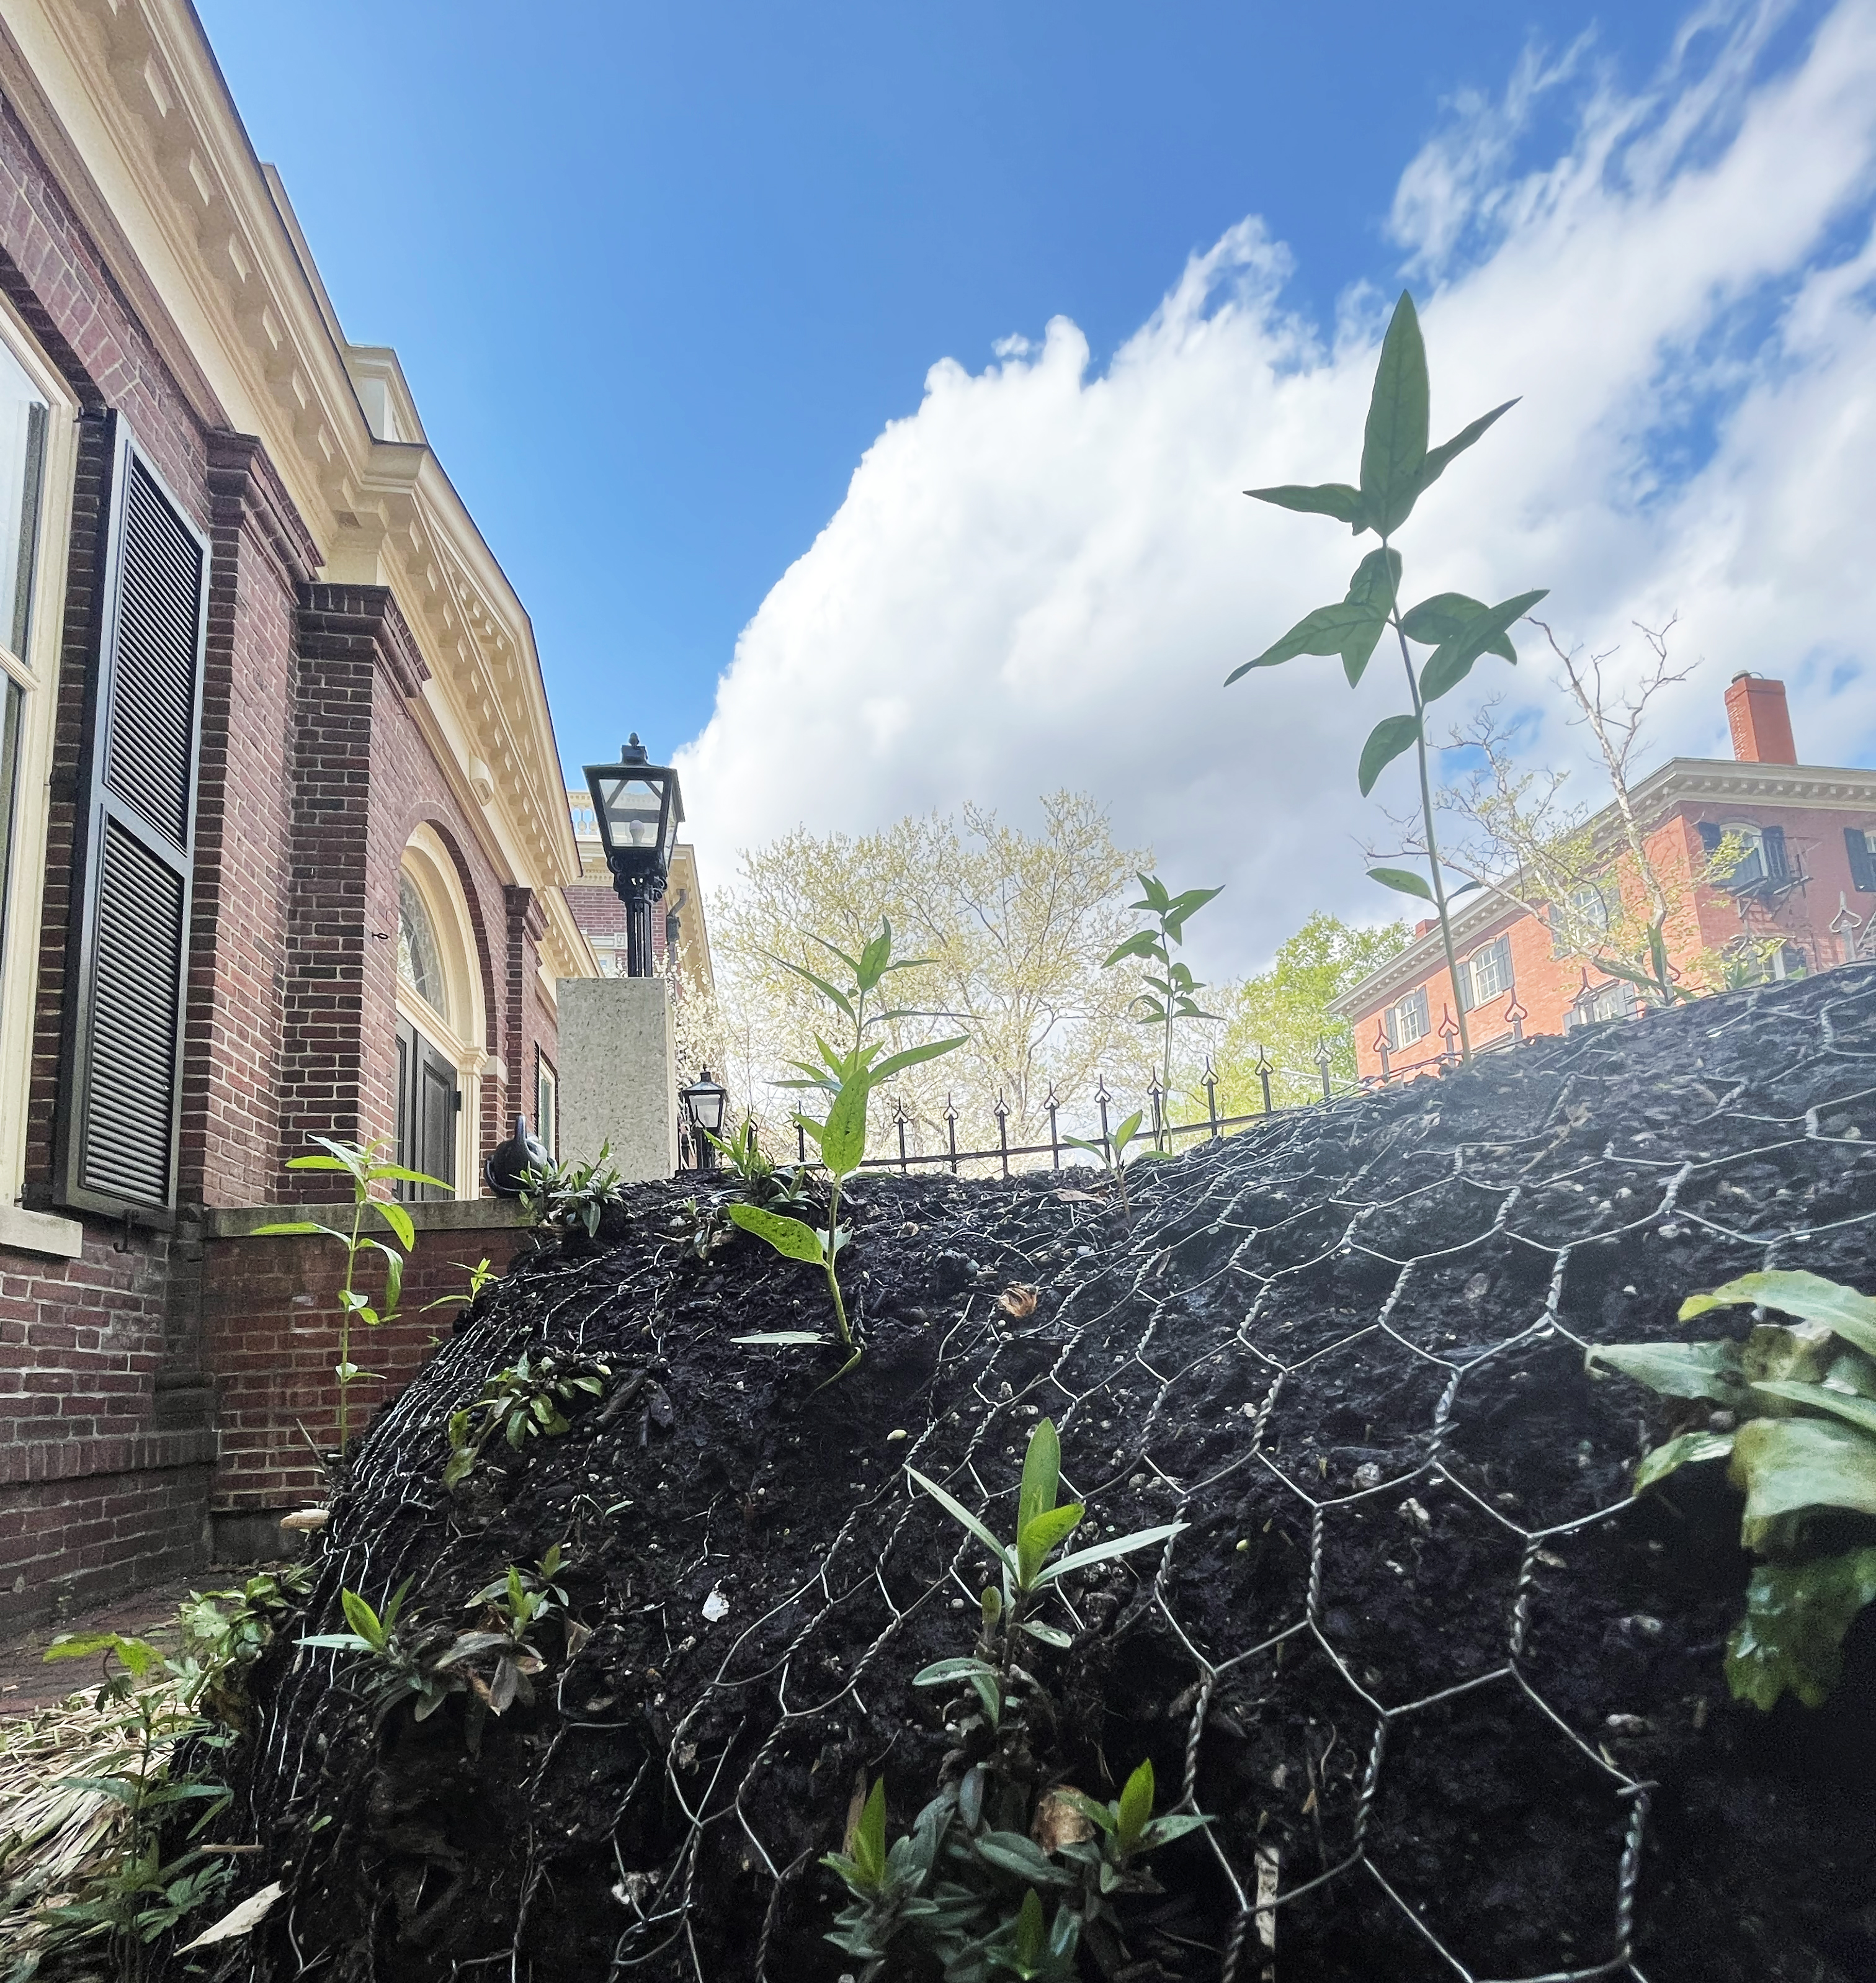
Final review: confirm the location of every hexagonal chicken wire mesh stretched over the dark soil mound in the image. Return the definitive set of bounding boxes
[238,968,1876,1983]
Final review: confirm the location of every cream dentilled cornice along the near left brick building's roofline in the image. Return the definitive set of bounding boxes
[0,0,579,890]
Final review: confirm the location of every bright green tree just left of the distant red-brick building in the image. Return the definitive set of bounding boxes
[1213,910,1408,1114]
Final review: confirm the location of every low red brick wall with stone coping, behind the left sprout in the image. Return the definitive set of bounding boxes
[202,1207,529,1513]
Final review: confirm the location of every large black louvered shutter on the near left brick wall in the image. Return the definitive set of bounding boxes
[60,414,208,1217]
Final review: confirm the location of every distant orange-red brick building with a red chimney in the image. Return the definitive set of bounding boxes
[1329,674,1876,1079]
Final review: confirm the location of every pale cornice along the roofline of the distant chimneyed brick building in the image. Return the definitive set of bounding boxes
[1327,758,1876,1019]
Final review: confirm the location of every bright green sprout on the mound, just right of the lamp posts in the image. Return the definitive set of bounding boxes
[728,918,964,1384]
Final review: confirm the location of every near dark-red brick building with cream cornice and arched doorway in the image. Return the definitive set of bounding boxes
[0,0,597,1632]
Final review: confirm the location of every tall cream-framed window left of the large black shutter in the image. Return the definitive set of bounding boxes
[0,302,78,1206]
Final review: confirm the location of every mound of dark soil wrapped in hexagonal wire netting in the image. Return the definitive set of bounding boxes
[212,970,1876,1983]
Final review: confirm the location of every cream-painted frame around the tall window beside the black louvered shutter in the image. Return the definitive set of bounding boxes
[0,297,79,1213]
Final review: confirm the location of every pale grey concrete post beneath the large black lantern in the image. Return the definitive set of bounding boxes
[557,978,678,1184]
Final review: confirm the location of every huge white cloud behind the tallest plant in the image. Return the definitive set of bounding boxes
[678,0,1876,970]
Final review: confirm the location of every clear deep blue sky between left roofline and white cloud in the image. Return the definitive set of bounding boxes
[199,0,1697,763]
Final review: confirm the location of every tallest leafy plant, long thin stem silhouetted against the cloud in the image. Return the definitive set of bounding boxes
[1226,292,1545,1061]
